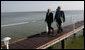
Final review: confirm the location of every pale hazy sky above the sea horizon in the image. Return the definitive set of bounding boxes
[1,1,84,12]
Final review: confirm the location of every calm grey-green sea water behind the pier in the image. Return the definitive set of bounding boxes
[1,10,84,41]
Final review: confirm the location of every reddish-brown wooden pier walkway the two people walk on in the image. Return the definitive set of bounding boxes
[1,21,84,49]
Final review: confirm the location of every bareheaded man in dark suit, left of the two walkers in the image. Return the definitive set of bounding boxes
[45,9,54,35]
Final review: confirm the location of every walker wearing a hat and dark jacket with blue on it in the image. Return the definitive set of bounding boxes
[54,6,65,33]
